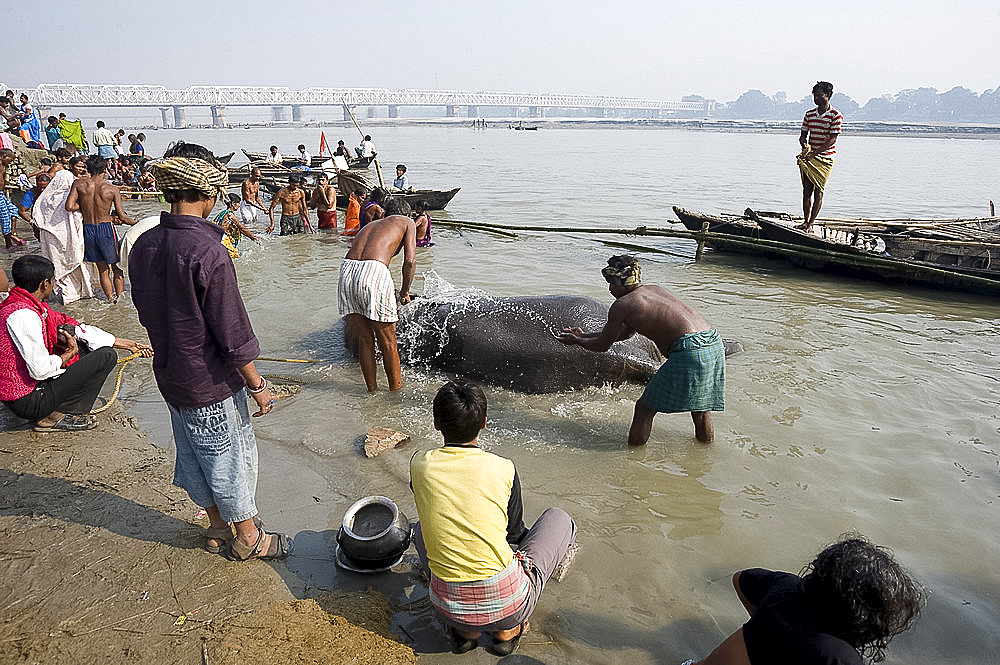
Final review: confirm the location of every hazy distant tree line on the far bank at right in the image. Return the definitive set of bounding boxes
[683,86,1000,123]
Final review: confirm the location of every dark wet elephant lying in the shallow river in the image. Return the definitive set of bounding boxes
[345,295,742,394]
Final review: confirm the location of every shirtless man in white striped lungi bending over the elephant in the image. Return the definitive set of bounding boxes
[337,200,417,393]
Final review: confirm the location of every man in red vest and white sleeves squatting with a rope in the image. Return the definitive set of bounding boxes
[0,254,153,432]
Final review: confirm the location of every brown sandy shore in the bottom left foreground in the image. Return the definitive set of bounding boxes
[0,405,416,665]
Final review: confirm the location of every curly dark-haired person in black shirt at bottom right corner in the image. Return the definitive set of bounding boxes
[685,534,925,665]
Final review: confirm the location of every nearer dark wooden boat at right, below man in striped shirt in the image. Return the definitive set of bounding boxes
[682,202,1000,297]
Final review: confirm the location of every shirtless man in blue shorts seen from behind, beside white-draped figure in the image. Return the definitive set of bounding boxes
[66,155,135,302]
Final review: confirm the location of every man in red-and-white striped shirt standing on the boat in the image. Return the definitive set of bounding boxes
[795,81,844,233]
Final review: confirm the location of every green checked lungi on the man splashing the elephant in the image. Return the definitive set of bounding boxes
[639,330,726,413]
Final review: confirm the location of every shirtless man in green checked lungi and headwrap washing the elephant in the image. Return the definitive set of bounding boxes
[558,256,726,446]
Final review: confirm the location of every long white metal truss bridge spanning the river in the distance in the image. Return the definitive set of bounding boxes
[24,83,715,127]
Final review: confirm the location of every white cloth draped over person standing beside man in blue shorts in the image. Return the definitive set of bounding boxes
[31,169,94,305]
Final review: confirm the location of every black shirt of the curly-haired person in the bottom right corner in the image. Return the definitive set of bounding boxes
[739,568,864,665]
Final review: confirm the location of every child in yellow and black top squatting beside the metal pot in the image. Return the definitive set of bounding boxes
[410,379,577,656]
